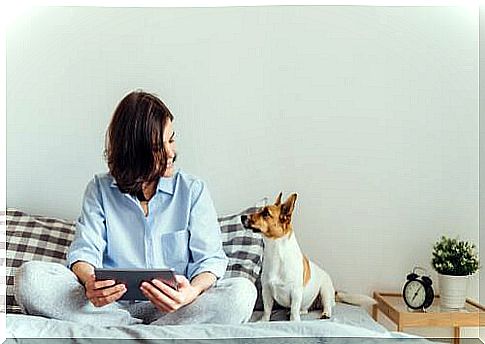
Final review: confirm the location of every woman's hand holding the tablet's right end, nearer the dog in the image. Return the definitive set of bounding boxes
[140,275,201,313]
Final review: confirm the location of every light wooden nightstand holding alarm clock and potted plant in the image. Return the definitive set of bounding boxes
[372,292,485,344]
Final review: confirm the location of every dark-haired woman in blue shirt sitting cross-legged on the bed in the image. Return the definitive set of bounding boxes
[15,91,256,326]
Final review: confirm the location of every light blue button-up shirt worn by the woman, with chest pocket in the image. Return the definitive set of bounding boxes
[67,170,228,280]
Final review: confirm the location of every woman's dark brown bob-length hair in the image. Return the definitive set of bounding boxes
[104,91,173,196]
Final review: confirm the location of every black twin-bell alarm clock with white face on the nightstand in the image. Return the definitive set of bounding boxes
[402,267,434,310]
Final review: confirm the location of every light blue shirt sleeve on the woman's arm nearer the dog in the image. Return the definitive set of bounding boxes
[187,181,228,280]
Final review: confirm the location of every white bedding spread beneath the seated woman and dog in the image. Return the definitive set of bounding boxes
[6,304,427,343]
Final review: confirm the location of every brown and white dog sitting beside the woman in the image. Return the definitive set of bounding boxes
[241,193,376,321]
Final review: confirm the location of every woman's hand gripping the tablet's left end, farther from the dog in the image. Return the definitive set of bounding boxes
[84,274,126,307]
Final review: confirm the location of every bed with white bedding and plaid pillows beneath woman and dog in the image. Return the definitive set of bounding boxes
[4,208,429,343]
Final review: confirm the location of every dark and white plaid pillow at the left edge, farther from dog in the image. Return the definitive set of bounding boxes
[2,209,75,313]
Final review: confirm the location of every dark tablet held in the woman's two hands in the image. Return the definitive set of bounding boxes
[94,269,177,300]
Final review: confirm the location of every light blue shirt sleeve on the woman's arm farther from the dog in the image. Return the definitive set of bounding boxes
[67,177,106,268]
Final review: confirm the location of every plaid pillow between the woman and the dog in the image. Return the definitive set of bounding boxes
[218,207,263,283]
